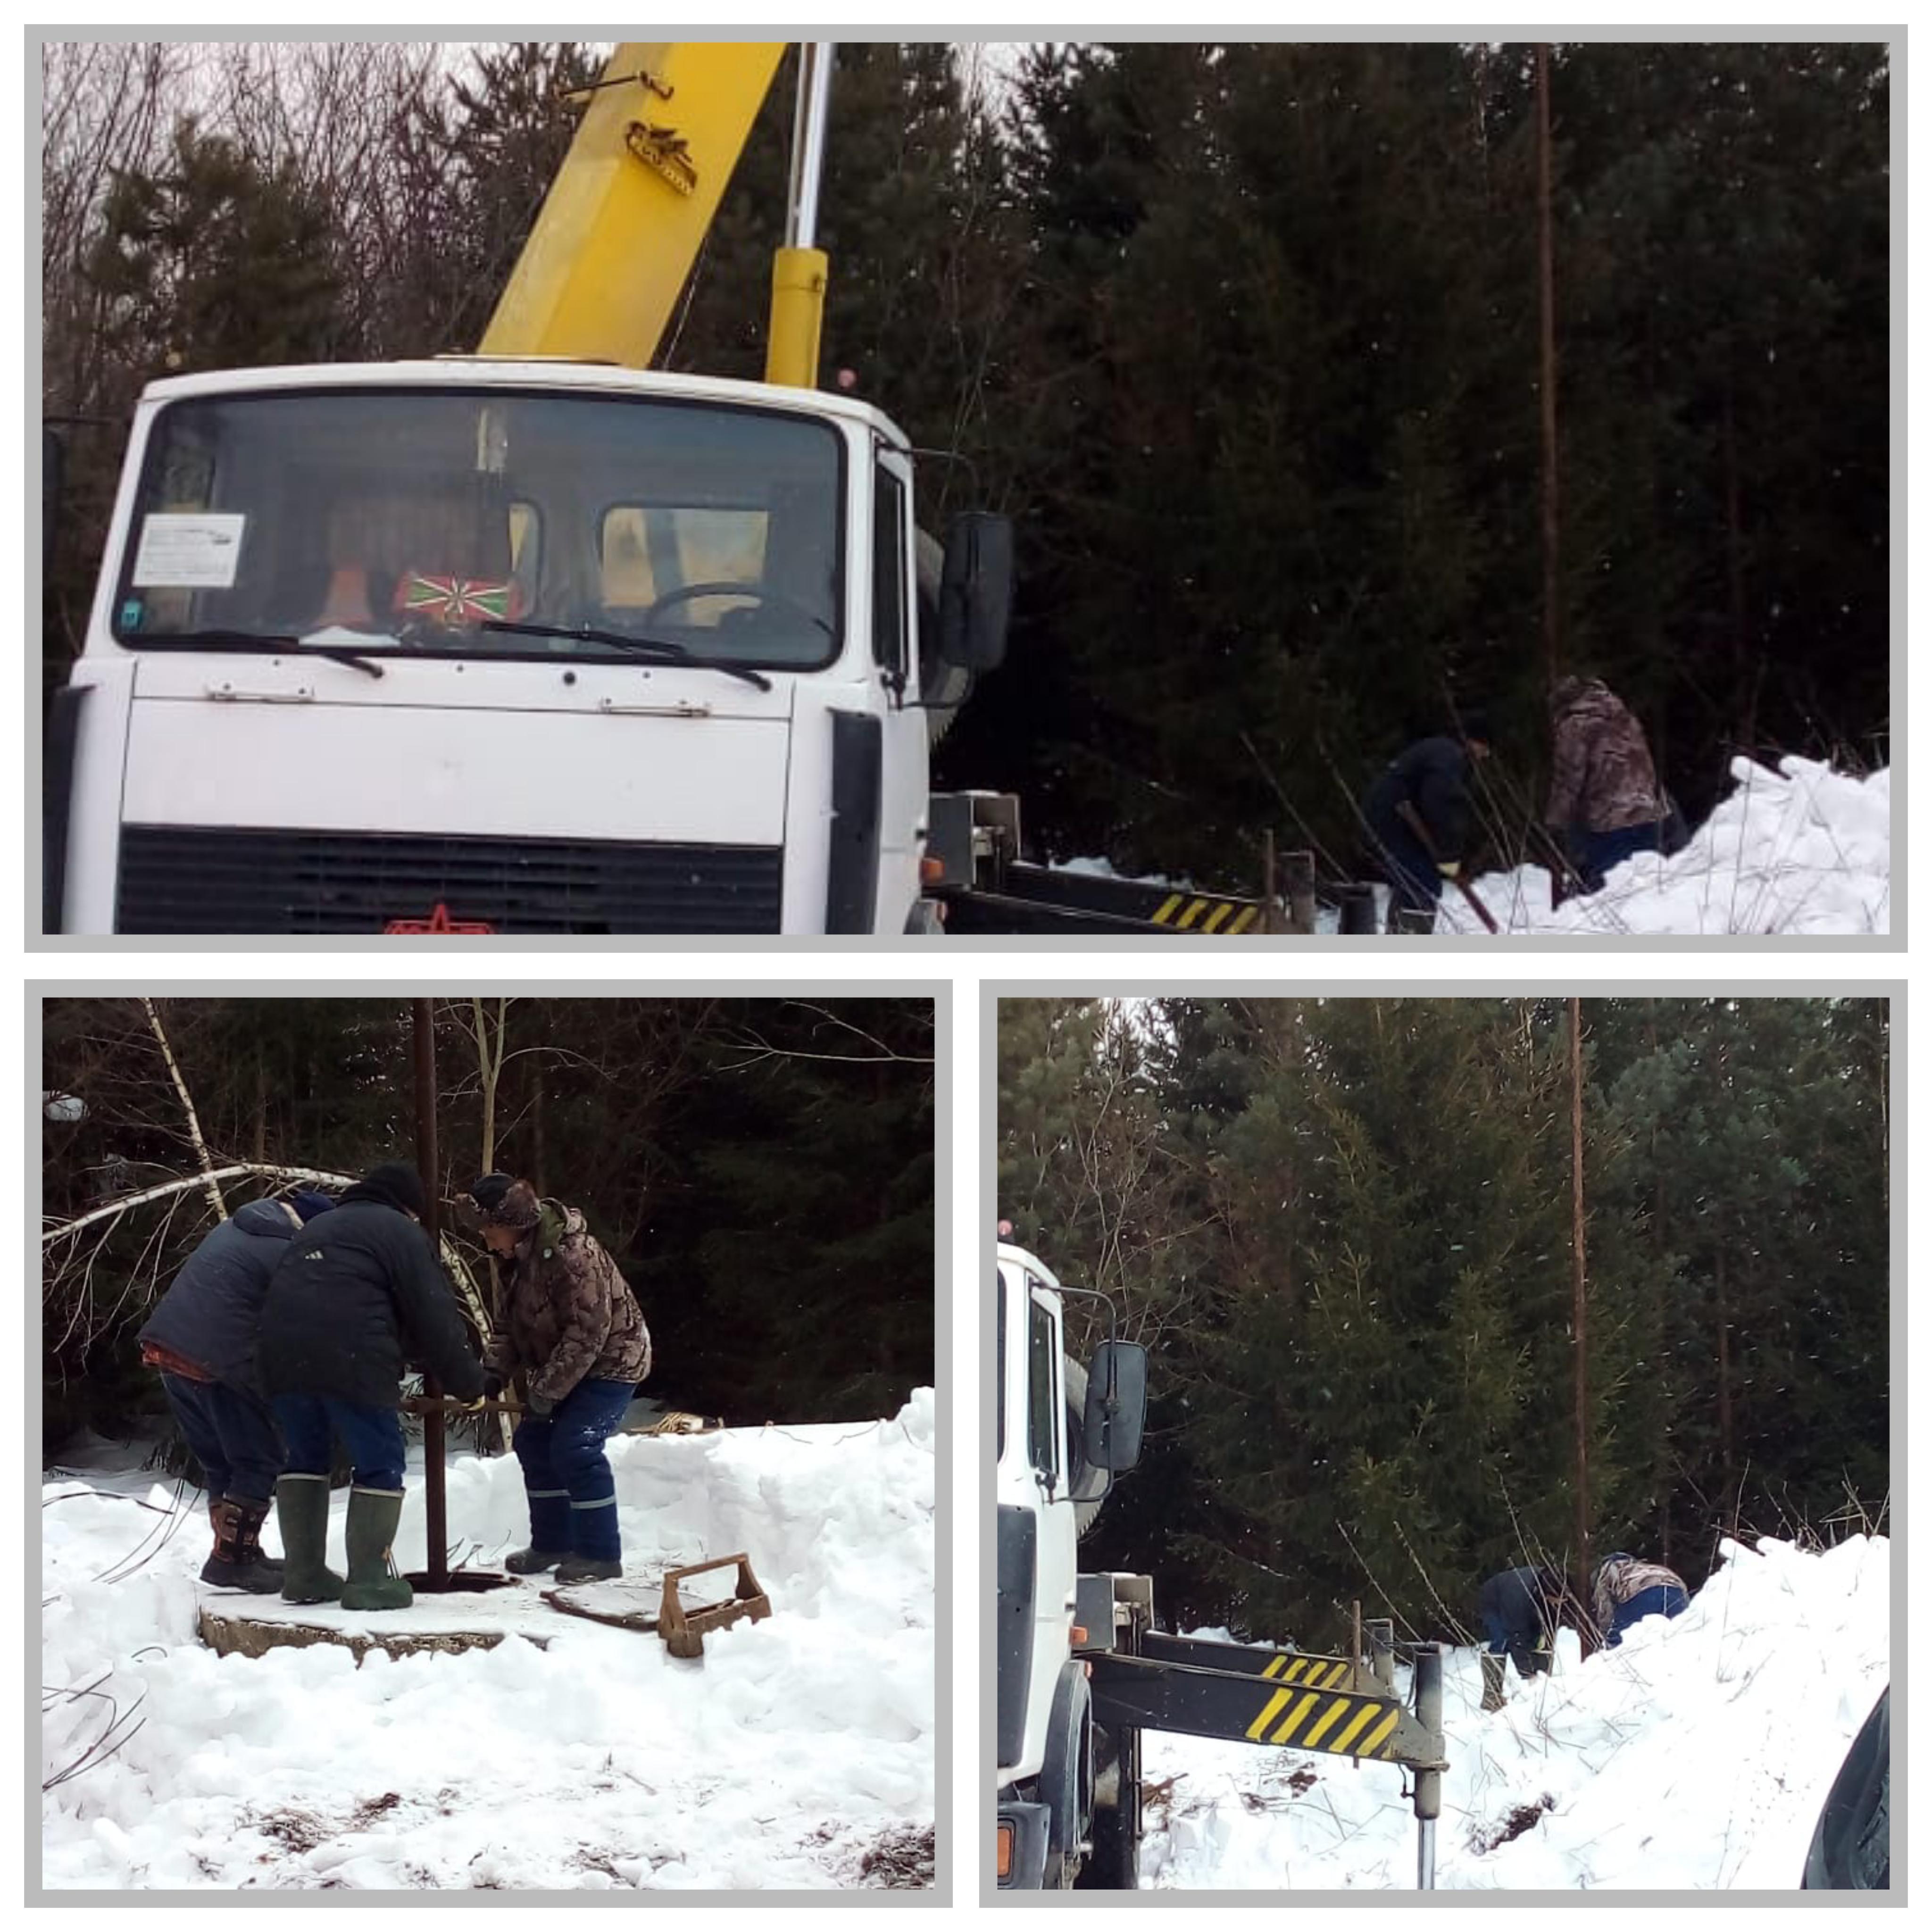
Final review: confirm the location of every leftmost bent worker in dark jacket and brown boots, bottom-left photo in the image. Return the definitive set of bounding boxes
[139,1188,330,1596]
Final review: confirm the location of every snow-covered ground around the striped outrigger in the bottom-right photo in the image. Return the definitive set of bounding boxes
[1140,1536,1891,1891]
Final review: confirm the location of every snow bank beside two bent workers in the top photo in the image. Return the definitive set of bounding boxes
[1435,758,1891,935]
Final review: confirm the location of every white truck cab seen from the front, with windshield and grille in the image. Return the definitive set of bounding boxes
[46,358,1008,933]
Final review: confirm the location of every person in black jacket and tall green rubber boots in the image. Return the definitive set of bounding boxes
[261,1161,483,1609]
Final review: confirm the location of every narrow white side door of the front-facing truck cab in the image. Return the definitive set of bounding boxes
[871,448,927,933]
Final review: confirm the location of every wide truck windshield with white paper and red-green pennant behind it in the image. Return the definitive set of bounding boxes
[110,388,842,670]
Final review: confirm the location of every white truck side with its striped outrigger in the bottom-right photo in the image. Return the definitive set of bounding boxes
[995,1229,1447,1891]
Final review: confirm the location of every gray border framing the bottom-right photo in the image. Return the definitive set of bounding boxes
[968,972,1911,1911]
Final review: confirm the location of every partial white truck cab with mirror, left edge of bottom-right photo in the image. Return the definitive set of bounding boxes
[993,1242,1146,1890]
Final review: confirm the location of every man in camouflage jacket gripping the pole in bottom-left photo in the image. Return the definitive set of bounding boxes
[469,1174,651,1582]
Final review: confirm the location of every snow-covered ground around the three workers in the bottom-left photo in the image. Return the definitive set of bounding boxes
[41,1389,935,1890]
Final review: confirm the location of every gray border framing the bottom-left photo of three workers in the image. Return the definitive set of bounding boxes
[34,974,960,1911]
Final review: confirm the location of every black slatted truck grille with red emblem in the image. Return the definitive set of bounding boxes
[114,825,784,933]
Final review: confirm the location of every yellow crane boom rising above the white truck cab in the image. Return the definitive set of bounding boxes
[481,41,784,371]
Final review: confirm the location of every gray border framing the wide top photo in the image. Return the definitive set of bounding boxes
[21,19,1911,950]
